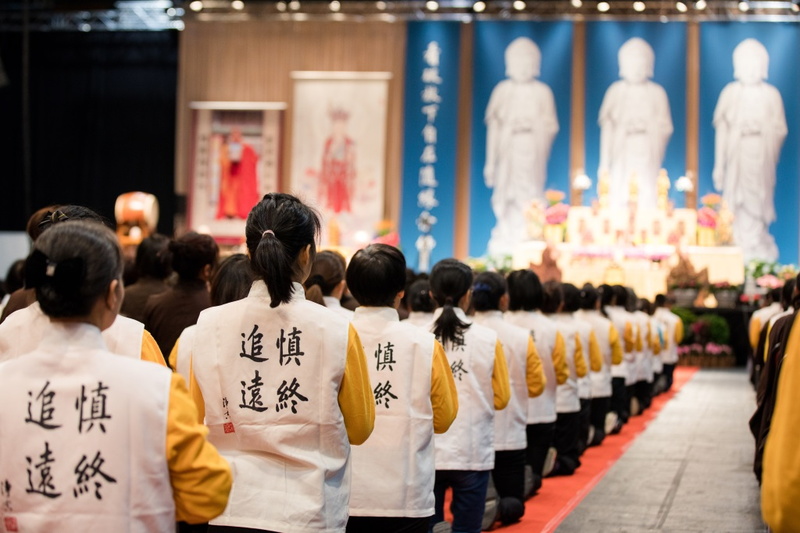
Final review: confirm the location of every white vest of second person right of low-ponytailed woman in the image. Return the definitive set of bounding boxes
[506,311,558,424]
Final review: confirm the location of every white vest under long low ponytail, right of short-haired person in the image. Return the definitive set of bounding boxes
[426,307,497,470]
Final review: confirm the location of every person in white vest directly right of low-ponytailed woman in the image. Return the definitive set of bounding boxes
[472,272,546,524]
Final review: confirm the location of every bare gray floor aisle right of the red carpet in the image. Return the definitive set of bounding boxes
[557,369,766,533]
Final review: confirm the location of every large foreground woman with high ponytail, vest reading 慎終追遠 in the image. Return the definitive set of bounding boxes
[191,193,375,533]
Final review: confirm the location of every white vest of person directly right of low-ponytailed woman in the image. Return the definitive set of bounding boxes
[475,311,531,450]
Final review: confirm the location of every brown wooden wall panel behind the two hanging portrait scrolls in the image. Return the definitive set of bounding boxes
[175,20,406,227]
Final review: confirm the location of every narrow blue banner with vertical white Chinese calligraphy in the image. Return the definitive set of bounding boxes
[400,21,461,271]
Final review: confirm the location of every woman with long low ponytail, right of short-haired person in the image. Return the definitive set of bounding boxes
[430,259,511,533]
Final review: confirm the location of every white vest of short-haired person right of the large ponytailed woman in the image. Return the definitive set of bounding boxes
[350,307,435,518]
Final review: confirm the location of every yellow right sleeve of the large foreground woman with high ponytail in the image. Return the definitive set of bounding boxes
[339,325,375,444]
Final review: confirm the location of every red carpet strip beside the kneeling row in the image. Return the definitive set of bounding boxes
[506,367,697,533]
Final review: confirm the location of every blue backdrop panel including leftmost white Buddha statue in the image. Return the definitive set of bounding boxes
[469,21,573,257]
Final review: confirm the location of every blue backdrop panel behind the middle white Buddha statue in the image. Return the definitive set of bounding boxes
[584,22,686,207]
